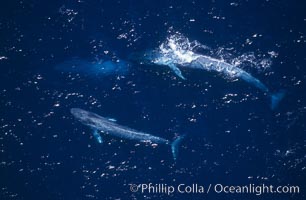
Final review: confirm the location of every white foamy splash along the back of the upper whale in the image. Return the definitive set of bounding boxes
[153,32,277,72]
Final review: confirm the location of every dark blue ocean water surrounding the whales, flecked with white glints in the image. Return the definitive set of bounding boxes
[0,0,306,200]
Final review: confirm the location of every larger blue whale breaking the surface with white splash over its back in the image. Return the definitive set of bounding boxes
[136,35,285,110]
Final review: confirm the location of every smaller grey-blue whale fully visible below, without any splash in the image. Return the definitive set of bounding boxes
[70,108,184,160]
